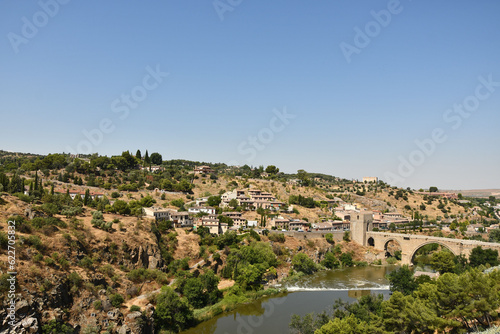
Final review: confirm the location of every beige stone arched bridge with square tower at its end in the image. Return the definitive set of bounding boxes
[351,213,500,265]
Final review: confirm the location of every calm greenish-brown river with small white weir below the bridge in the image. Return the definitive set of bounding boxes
[182,266,396,334]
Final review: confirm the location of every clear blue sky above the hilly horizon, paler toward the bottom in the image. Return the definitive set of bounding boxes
[0,0,500,189]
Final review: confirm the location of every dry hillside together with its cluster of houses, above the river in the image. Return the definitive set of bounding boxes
[0,150,500,333]
